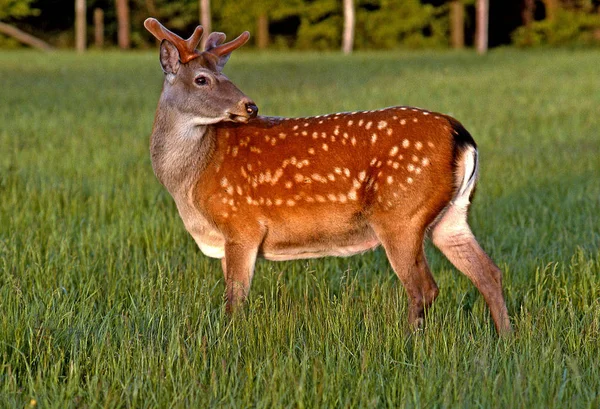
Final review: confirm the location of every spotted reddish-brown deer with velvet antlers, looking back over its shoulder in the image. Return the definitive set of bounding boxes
[144,18,511,335]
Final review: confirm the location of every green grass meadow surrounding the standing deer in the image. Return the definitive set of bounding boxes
[0,50,600,408]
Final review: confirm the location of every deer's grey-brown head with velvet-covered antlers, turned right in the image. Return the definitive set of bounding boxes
[144,18,258,125]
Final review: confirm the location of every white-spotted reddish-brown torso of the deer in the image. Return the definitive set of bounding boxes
[152,107,460,260]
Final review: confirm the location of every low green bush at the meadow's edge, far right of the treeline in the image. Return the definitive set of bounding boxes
[512,9,600,47]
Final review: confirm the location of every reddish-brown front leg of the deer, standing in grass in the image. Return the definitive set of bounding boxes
[221,242,258,313]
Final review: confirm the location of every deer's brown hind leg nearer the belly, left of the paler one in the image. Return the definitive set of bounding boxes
[372,217,439,328]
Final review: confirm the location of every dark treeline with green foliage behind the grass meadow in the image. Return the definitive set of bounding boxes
[0,0,600,49]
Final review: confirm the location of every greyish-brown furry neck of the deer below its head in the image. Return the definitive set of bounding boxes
[150,100,215,194]
